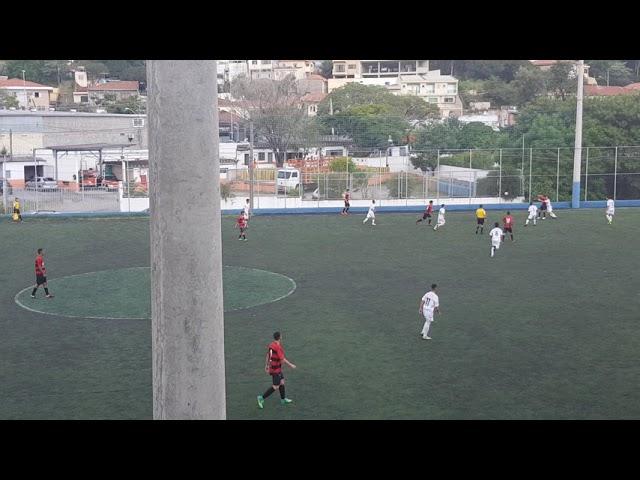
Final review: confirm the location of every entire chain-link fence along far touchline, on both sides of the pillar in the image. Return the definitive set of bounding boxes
[2,146,640,213]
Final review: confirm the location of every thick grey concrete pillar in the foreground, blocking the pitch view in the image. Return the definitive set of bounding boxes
[147,60,226,419]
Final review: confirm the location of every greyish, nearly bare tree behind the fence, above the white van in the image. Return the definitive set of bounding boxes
[231,75,309,167]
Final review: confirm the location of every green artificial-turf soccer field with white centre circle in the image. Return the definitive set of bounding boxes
[0,208,640,419]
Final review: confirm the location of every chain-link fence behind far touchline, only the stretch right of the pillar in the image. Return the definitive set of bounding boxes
[219,147,640,206]
